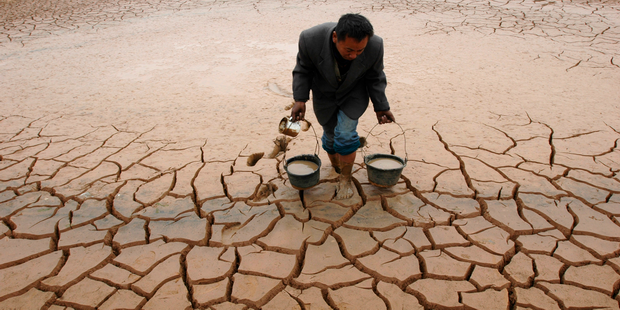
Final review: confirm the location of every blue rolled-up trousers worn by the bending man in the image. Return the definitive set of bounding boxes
[321,110,360,155]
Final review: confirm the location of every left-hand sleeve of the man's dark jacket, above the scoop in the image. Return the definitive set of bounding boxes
[293,32,314,102]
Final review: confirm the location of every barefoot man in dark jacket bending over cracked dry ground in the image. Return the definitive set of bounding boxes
[291,14,395,199]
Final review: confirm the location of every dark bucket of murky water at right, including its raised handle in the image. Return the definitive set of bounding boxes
[364,123,407,187]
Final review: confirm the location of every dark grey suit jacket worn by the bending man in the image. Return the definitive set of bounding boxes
[293,23,390,125]
